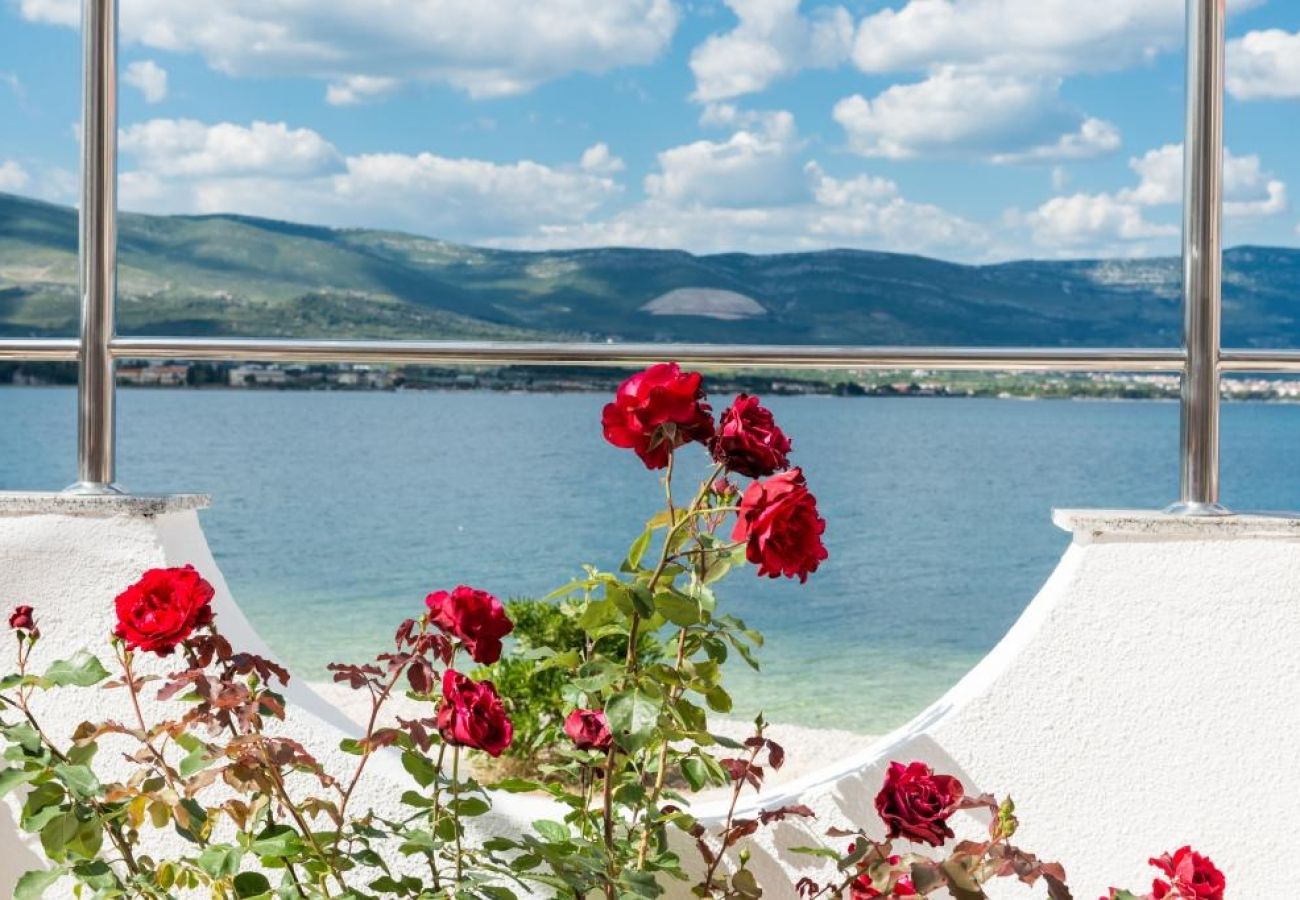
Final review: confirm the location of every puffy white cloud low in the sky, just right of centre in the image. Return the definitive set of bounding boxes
[645,111,809,207]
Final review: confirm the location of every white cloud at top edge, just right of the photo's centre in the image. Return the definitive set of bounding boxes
[690,0,854,103]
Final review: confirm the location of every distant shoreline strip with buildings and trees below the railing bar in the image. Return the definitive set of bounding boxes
[0,360,1300,403]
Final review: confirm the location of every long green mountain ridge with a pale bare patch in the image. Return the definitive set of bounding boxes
[0,194,1300,347]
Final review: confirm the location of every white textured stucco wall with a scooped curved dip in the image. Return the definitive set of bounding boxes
[0,496,1300,900]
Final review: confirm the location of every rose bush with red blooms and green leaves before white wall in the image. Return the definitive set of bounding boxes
[0,364,1223,900]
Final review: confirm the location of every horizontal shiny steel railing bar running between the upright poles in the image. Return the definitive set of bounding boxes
[0,337,1300,373]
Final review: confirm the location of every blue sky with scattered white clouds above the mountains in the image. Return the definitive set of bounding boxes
[0,0,1300,261]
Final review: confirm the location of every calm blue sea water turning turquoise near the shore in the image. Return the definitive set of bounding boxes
[0,388,1300,732]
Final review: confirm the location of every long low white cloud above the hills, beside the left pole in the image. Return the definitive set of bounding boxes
[121,120,621,241]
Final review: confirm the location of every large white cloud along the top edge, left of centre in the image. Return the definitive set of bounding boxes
[18,0,679,96]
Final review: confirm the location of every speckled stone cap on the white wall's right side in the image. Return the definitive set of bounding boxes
[1052,510,1300,544]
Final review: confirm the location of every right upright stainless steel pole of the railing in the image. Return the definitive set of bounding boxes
[1171,0,1227,515]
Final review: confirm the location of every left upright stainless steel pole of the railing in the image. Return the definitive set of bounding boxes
[69,0,118,493]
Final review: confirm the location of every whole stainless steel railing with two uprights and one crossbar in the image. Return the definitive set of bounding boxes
[0,0,1268,515]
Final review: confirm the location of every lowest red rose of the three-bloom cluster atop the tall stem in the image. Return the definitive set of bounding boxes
[732,468,827,581]
